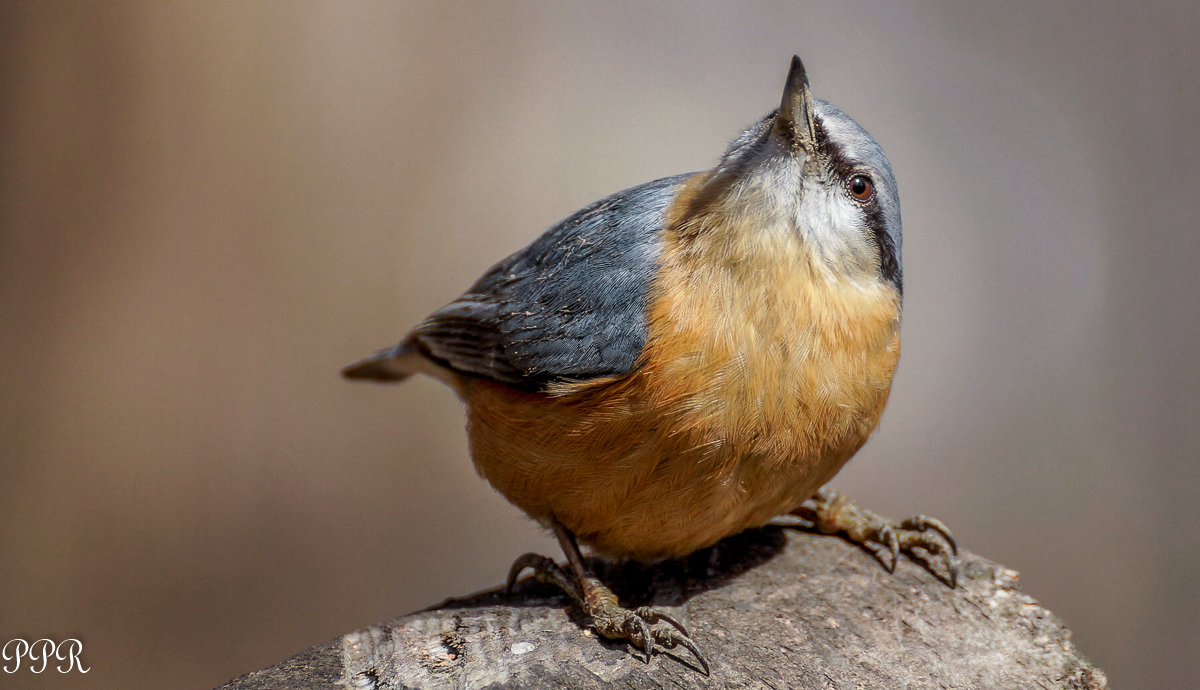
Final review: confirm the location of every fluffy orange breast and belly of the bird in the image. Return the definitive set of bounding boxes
[464,182,900,559]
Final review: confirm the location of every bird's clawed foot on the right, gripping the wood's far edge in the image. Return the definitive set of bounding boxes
[792,488,959,587]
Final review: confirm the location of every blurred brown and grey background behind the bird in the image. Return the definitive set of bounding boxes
[0,0,1200,688]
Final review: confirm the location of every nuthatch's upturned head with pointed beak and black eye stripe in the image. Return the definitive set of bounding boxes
[672,56,902,297]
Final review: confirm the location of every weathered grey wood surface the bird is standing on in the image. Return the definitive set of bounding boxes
[224,527,1108,690]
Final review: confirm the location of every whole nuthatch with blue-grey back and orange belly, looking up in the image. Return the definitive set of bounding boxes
[342,56,956,673]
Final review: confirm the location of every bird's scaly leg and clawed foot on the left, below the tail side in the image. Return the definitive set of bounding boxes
[509,520,708,676]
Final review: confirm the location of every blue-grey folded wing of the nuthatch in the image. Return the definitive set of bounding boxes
[406,175,688,390]
